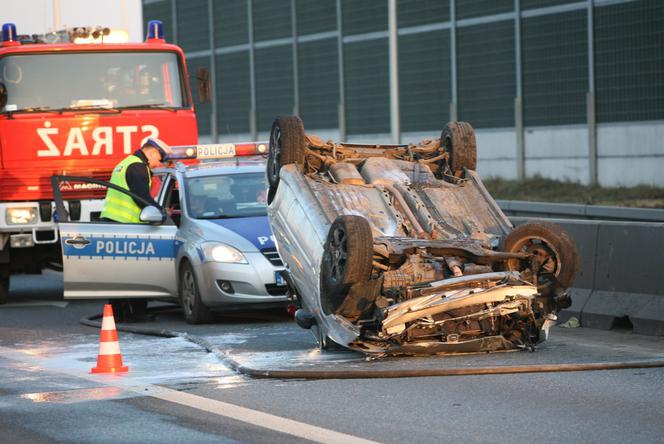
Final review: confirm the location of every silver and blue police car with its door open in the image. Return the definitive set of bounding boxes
[53,143,287,323]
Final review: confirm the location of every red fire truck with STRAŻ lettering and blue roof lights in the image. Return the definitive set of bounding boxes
[0,21,206,303]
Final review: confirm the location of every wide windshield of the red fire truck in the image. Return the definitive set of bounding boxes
[0,52,187,112]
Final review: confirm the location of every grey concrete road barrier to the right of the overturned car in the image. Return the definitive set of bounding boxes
[510,217,664,336]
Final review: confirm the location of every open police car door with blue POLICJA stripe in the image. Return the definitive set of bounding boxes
[52,176,177,299]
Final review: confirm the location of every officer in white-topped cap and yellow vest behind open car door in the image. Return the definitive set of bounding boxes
[101,138,172,224]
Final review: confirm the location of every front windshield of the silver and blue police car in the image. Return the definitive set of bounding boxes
[185,173,267,219]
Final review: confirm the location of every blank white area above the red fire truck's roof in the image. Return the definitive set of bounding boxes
[0,0,144,42]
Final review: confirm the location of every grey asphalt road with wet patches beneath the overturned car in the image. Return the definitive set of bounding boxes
[0,273,664,443]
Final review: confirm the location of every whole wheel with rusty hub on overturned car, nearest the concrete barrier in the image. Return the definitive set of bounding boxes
[502,222,579,291]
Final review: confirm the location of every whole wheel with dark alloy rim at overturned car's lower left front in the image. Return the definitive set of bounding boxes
[321,215,373,313]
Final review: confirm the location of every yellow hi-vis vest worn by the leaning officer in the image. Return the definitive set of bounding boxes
[101,154,152,224]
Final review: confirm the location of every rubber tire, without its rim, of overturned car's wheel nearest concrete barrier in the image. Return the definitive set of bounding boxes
[502,221,579,288]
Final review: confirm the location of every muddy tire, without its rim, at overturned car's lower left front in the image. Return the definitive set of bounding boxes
[322,215,373,289]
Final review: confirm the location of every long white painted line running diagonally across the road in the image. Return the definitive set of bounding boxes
[0,346,375,444]
